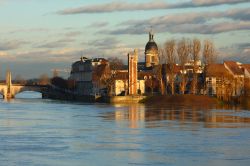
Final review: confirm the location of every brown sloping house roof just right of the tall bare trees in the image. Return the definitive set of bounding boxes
[206,64,230,77]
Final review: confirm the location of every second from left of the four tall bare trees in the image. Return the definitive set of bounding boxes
[177,39,190,94]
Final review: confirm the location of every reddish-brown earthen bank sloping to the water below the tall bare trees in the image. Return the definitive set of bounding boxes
[141,95,219,106]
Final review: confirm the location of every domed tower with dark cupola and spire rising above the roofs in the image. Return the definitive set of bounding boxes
[145,30,159,67]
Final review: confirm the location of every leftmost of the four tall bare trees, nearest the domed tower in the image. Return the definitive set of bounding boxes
[163,40,176,95]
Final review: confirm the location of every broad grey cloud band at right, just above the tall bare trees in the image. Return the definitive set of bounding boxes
[99,8,250,35]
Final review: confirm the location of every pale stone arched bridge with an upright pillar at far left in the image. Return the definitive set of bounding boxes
[0,72,48,99]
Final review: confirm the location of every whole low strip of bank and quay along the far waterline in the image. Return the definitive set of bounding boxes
[43,88,250,109]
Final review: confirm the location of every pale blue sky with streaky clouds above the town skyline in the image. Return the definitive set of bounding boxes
[0,0,250,78]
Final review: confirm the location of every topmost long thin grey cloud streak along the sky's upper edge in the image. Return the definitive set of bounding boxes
[57,0,249,15]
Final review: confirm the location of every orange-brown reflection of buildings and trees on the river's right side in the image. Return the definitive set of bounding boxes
[104,105,250,128]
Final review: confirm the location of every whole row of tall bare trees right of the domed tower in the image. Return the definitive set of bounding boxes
[157,39,217,95]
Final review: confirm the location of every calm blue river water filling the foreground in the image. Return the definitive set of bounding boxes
[0,93,250,166]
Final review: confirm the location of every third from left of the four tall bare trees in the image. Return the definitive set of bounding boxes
[190,39,201,94]
